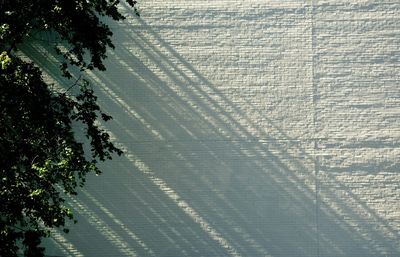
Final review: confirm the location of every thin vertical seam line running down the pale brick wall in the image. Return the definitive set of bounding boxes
[310,0,320,257]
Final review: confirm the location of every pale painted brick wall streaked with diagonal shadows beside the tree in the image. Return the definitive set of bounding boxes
[35,0,400,257]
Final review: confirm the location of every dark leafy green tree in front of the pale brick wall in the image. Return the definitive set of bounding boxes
[0,0,138,256]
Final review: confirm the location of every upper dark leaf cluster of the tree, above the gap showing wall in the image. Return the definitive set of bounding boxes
[0,0,139,74]
